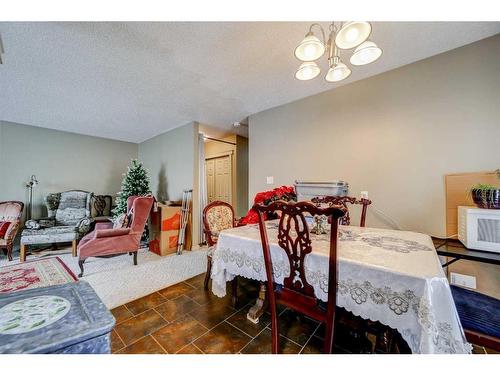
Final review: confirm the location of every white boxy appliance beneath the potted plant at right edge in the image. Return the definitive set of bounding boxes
[458,206,500,253]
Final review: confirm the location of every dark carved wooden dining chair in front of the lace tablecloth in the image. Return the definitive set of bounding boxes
[253,201,346,353]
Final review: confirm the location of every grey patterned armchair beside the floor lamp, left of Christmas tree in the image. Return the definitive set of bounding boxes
[20,190,93,262]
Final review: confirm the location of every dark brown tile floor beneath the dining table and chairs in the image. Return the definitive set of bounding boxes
[111,274,496,354]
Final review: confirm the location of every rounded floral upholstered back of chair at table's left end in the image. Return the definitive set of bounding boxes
[203,201,235,246]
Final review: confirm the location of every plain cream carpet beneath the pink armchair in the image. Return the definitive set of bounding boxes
[0,248,207,309]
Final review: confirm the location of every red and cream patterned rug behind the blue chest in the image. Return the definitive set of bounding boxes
[0,257,76,293]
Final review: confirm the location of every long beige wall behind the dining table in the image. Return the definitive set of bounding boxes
[249,35,500,298]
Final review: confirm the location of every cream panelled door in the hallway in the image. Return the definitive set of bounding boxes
[205,155,232,204]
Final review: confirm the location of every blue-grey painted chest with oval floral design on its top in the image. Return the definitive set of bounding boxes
[0,281,115,354]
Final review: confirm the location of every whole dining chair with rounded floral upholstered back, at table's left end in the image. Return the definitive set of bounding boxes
[203,201,238,305]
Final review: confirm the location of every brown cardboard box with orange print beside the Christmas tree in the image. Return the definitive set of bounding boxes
[149,203,191,256]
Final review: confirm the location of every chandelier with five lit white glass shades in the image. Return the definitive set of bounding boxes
[295,21,382,82]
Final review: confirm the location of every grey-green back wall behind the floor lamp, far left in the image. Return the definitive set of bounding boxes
[0,121,137,218]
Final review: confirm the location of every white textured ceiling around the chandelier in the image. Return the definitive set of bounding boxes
[0,22,500,142]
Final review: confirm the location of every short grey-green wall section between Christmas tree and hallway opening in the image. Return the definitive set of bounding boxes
[139,123,199,244]
